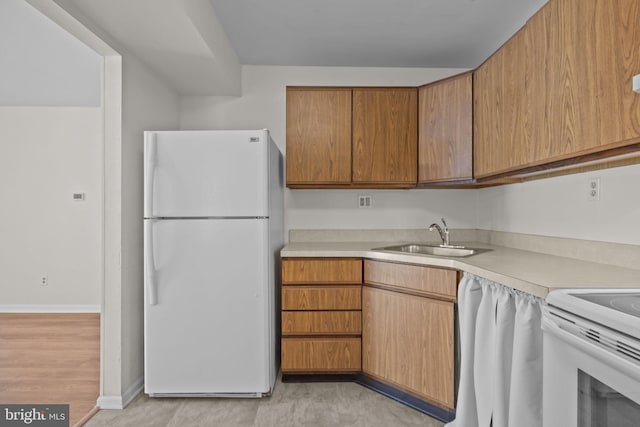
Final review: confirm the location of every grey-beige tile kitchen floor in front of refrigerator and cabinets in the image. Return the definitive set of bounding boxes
[85,381,443,427]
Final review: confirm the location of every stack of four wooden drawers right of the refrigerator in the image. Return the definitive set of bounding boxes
[281,258,362,375]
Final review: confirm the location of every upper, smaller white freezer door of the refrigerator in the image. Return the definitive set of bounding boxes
[144,130,269,218]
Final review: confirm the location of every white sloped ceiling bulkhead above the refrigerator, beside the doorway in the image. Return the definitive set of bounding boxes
[52,0,240,95]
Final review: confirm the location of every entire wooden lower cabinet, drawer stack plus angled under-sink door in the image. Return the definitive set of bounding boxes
[281,258,458,416]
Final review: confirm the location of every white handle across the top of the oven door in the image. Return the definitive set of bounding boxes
[542,313,640,381]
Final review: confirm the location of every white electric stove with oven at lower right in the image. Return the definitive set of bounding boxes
[542,288,640,427]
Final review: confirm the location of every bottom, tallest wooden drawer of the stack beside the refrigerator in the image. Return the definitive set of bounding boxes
[282,338,361,373]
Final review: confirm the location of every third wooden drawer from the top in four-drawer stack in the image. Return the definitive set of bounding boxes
[282,311,362,335]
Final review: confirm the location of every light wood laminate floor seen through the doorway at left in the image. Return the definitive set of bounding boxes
[0,313,100,426]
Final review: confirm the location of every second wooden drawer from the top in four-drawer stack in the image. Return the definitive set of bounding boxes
[282,286,362,310]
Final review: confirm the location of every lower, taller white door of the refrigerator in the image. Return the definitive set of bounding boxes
[144,219,275,395]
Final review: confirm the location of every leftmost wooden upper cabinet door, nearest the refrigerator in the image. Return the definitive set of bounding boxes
[286,88,351,185]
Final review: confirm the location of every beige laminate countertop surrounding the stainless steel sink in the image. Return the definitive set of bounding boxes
[281,242,640,298]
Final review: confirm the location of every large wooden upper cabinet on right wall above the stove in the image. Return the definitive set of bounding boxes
[474,0,640,178]
